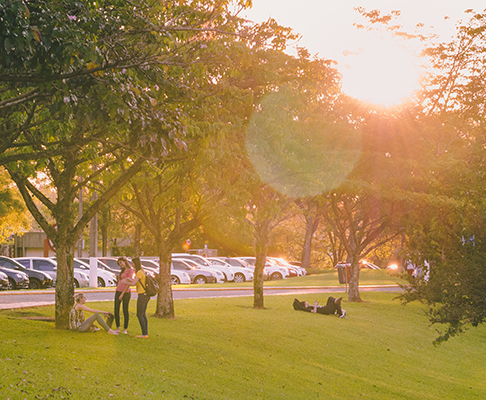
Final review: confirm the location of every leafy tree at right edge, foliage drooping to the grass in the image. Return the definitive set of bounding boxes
[403,11,486,343]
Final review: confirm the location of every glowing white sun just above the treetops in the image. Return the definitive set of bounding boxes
[340,41,419,106]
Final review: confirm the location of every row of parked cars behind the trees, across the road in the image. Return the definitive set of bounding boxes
[0,253,306,290]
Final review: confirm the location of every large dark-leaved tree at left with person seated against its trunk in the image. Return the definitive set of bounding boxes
[0,0,282,328]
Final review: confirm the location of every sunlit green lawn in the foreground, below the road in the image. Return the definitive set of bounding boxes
[0,292,486,400]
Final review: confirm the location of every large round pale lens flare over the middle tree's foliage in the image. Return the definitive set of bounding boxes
[246,90,361,198]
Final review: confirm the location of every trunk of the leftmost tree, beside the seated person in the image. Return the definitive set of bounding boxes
[55,239,74,329]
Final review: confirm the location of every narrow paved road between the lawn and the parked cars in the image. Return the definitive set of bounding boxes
[0,285,401,310]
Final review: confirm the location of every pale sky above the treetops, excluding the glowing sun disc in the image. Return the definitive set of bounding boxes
[243,0,486,62]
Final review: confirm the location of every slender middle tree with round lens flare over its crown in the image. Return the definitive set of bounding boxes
[202,49,350,308]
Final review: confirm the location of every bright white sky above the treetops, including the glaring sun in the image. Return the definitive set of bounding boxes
[241,0,486,106]
